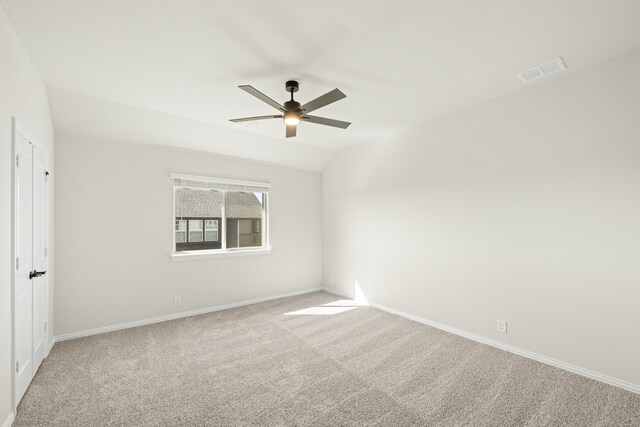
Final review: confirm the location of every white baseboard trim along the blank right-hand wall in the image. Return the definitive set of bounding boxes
[322,287,640,394]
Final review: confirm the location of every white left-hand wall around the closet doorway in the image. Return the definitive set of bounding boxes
[0,3,55,424]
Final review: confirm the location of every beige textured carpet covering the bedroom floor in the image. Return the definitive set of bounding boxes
[14,292,640,427]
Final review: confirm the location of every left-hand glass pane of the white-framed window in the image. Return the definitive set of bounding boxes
[175,186,223,251]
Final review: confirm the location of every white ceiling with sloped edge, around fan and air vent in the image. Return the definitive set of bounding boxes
[0,0,640,171]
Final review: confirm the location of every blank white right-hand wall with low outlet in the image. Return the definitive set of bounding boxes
[323,53,640,384]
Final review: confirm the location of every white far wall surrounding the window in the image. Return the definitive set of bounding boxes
[55,139,322,335]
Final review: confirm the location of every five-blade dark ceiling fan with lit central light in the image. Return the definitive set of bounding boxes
[230,80,351,138]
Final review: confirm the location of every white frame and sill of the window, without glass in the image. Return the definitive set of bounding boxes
[169,173,271,261]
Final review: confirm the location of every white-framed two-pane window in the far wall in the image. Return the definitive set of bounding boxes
[171,174,270,259]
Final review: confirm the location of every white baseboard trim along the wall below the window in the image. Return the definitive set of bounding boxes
[51,287,323,346]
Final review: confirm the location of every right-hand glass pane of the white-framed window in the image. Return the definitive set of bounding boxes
[225,191,266,248]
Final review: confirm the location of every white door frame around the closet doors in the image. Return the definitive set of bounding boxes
[11,116,51,414]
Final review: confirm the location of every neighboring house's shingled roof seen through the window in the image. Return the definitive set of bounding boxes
[176,188,262,218]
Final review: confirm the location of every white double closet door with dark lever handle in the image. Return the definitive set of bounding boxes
[14,123,47,406]
